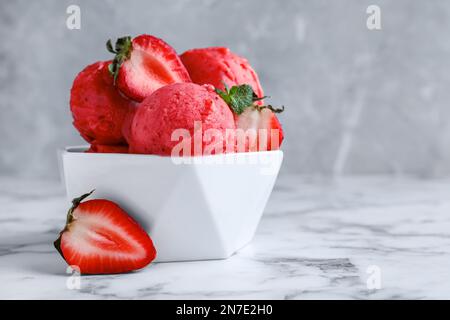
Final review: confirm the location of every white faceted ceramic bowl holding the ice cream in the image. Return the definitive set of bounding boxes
[61,147,283,261]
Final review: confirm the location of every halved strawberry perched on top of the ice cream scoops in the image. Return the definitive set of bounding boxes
[106,34,191,102]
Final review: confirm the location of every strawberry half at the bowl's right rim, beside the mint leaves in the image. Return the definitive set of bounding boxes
[235,106,284,152]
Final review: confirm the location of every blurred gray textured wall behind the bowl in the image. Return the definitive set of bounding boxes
[0,0,450,177]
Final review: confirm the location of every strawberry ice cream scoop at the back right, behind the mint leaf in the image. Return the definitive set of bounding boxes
[180,47,264,103]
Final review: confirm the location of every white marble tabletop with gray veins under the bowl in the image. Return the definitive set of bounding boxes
[0,176,450,299]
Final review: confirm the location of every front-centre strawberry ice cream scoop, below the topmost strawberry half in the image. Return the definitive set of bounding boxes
[129,83,235,156]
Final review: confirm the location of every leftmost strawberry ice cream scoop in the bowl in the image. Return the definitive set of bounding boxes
[70,61,133,145]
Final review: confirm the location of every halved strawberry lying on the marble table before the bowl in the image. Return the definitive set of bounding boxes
[54,191,156,274]
